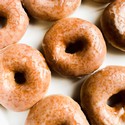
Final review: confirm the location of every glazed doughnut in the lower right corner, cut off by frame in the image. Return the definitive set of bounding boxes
[80,66,125,125]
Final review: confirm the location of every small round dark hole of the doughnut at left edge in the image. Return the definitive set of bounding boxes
[14,71,26,84]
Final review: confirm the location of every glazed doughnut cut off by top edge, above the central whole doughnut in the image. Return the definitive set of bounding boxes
[22,0,81,21]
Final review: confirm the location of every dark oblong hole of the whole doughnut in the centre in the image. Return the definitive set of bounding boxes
[65,39,86,54]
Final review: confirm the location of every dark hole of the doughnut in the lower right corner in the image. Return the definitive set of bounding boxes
[107,90,125,107]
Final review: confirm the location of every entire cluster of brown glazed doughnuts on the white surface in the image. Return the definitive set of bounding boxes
[0,0,125,125]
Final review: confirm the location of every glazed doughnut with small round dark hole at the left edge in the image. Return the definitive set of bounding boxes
[0,44,51,111]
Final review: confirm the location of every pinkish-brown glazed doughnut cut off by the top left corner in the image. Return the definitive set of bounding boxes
[0,0,29,49]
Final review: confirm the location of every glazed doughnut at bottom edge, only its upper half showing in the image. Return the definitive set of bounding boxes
[25,95,89,125]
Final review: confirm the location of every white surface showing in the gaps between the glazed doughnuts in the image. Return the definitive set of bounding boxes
[0,1,125,125]
